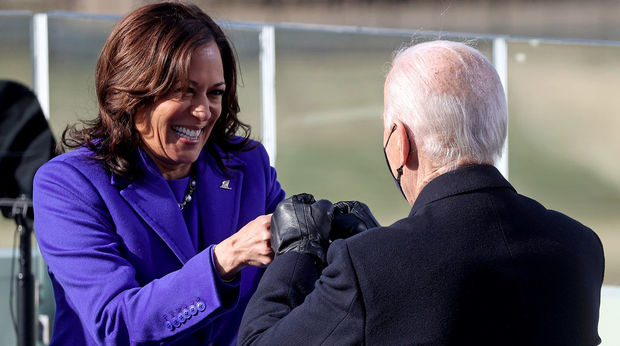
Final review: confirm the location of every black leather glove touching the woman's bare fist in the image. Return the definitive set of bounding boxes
[271,193,334,265]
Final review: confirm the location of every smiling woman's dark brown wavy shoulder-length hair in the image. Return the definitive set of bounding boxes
[60,2,252,179]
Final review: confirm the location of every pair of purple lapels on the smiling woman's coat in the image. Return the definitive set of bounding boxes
[111,148,245,264]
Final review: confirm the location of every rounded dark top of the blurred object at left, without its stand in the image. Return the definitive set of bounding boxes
[0,80,56,218]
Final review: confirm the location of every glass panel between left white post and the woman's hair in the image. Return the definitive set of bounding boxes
[48,15,116,139]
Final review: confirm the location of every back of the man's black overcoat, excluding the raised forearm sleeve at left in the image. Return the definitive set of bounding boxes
[347,165,604,345]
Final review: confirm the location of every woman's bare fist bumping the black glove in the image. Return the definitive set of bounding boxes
[213,214,273,280]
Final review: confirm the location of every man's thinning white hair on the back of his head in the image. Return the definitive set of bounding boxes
[384,41,508,169]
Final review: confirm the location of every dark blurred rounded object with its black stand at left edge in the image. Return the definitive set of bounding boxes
[0,80,56,346]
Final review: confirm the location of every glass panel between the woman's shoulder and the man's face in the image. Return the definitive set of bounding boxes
[276,28,490,225]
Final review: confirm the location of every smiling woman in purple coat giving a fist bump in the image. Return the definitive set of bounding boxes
[33,3,284,345]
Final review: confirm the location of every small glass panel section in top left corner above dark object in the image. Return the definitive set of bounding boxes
[0,11,32,88]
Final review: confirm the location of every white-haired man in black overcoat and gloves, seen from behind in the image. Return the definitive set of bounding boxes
[239,41,604,345]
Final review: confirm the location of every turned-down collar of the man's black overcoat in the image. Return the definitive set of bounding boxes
[409,165,516,216]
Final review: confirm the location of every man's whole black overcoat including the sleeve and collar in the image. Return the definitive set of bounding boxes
[239,165,604,346]
